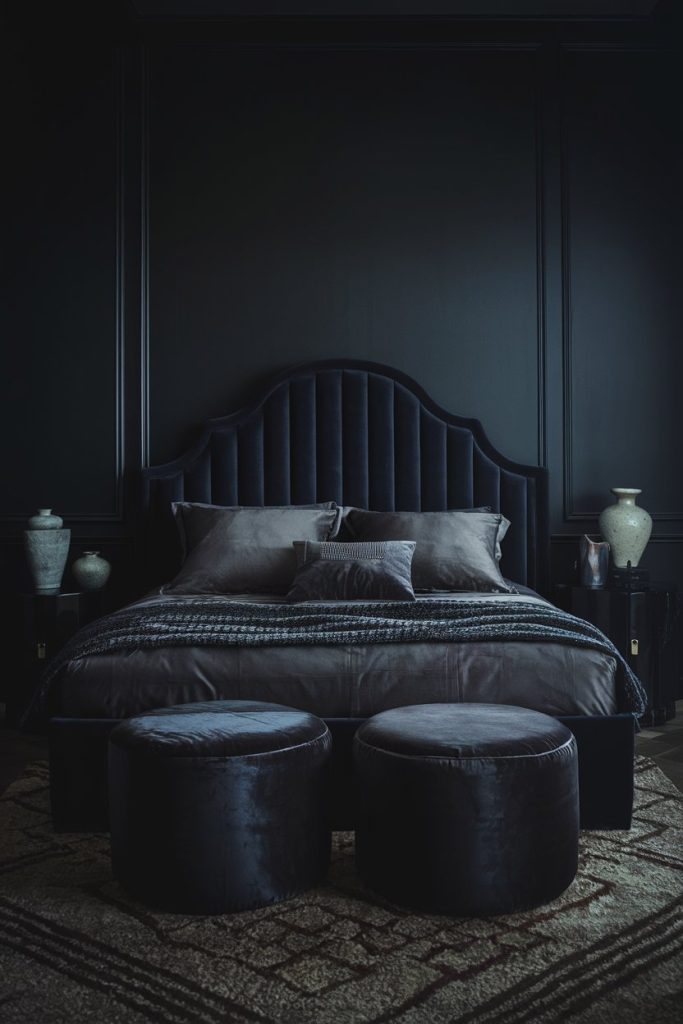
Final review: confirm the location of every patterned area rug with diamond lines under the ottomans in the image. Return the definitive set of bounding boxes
[0,758,683,1024]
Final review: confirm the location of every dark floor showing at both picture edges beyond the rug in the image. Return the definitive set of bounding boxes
[0,700,683,793]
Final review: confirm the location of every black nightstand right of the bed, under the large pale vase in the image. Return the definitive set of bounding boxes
[553,584,681,725]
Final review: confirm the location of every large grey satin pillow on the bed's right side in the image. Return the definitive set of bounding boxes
[346,509,516,594]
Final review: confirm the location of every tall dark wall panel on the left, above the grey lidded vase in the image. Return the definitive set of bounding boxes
[0,37,121,521]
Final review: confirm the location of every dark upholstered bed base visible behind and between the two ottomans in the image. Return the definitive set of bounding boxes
[49,715,635,831]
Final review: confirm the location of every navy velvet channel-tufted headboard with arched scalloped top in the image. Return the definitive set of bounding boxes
[142,359,549,593]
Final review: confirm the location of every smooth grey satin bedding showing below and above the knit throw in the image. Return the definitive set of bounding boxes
[53,593,616,718]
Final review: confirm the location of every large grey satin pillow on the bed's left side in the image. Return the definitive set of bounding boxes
[162,505,340,594]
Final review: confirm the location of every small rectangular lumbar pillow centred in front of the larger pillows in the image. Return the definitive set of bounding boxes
[287,541,415,601]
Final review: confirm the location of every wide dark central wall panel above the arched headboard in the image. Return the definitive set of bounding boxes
[148,43,539,462]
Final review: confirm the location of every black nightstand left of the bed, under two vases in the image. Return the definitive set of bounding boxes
[7,591,108,725]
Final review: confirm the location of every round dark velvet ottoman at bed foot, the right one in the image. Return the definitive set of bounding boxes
[354,705,579,915]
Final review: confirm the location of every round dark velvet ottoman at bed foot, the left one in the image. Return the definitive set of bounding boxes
[109,700,332,913]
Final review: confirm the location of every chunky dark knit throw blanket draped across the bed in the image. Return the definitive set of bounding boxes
[26,597,646,725]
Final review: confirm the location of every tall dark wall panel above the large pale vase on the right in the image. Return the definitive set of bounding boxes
[564,51,683,520]
